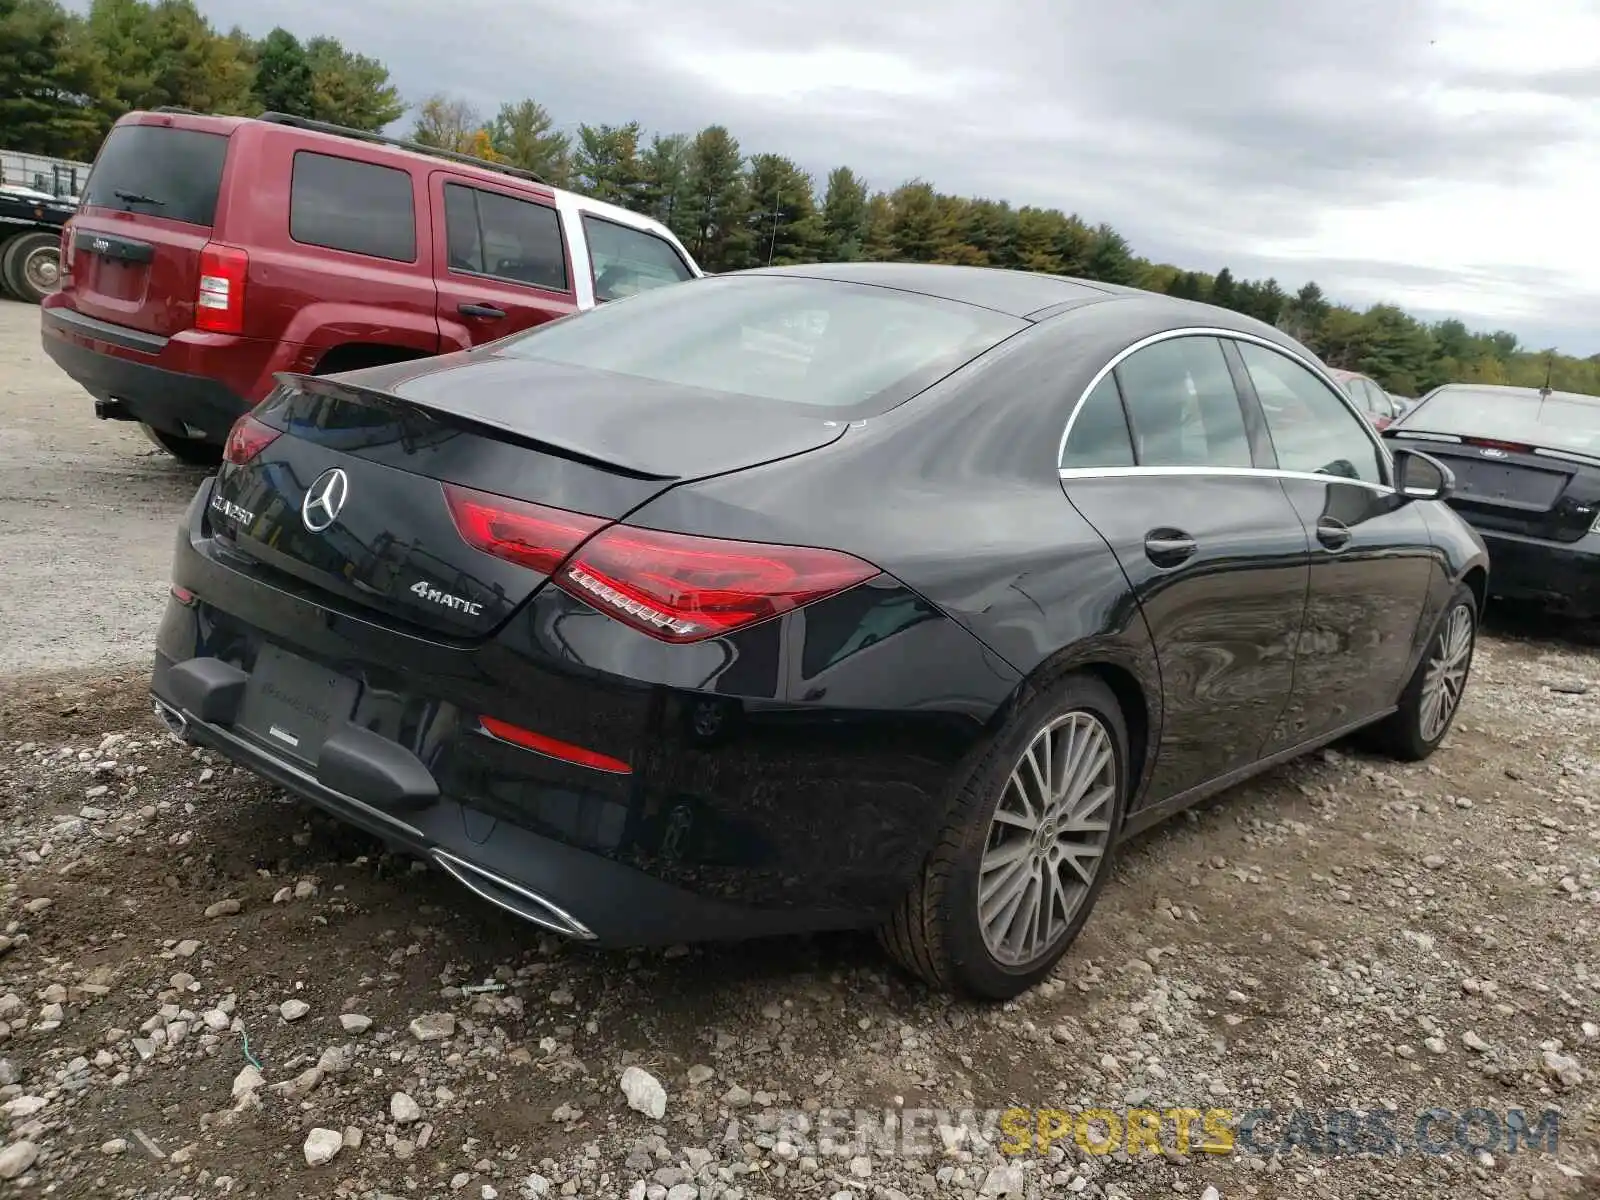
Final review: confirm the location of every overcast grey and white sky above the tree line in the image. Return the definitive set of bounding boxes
[168,0,1600,355]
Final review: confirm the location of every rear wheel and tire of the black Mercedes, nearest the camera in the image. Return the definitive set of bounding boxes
[878,675,1130,1000]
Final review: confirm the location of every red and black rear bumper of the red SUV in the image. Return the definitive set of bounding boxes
[40,305,275,442]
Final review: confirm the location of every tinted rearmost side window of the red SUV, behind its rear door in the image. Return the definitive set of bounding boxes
[290,150,416,262]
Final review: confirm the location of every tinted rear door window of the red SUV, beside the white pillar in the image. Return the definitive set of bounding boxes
[445,184,566,291]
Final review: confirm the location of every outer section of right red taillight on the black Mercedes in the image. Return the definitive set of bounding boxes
[555,525,878,642]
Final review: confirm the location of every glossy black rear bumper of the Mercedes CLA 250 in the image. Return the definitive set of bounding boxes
[152,480,1018,946]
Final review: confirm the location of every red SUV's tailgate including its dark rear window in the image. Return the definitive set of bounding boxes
[64,122,229,336]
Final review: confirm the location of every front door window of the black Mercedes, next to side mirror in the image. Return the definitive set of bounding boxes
[1238,342,1387,483]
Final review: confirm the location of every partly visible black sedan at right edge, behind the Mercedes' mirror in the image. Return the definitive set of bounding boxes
[1387,384,1600,619]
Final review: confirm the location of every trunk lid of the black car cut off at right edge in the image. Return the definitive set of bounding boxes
[1390,429,1600,542]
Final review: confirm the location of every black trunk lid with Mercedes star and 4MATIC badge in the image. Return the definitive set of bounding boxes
[210,364,845,640]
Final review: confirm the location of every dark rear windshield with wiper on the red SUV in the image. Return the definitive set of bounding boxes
[83,125,227,226]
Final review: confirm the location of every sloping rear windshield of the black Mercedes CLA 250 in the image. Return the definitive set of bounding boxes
[496,275,1027,416]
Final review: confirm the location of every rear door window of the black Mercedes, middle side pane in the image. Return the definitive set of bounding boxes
[1117,338,1253,467]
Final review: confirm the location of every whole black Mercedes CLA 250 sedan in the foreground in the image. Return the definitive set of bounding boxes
[154,264,1488,997]
